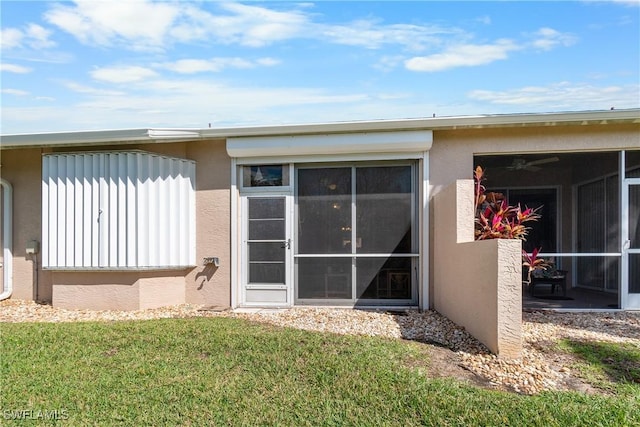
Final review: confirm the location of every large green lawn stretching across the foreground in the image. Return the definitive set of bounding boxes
[0,318,640,426]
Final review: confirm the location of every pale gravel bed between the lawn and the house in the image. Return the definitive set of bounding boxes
[0,300,640,394]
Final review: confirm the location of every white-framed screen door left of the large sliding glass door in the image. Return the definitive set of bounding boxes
[242,194,291,306]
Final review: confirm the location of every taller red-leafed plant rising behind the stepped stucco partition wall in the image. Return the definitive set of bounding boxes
[473,166,540,240]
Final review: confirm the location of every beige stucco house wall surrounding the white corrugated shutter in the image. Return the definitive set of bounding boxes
[0,140,231,310]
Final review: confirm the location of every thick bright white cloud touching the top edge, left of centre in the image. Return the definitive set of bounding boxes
[45,0,307,50]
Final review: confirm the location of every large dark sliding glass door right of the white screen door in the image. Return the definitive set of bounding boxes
[295,164,418,305]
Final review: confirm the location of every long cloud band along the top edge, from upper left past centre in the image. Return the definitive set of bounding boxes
[40,0,463,50]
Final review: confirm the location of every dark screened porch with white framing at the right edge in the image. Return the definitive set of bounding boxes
[474,150,640,309]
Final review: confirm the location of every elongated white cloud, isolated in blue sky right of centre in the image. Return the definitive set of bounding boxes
[404,39,521,72]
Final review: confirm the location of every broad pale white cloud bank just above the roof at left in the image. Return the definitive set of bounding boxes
[13,79,376,133]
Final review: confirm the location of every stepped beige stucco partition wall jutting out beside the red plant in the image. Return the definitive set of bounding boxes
[432,180,522,357]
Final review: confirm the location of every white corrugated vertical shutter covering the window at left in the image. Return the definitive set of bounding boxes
[42,151,195,270]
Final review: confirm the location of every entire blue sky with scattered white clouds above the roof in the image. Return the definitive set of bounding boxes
[0,0,640,134]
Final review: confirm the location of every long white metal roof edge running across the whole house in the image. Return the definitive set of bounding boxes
[0,109,640,149]
